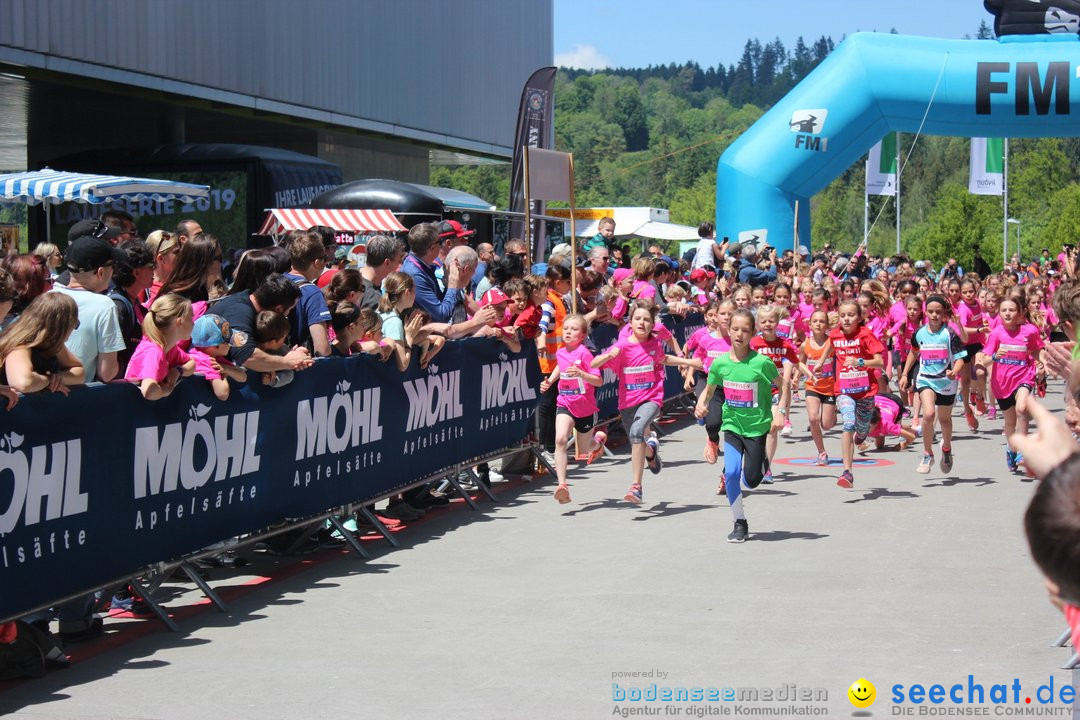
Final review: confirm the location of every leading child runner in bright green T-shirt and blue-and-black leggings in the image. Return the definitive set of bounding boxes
[694,309,783,543]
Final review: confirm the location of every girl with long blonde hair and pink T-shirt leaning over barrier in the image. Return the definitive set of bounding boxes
[124,293,195,400]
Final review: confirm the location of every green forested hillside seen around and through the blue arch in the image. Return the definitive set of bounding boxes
[432,23,1080,269]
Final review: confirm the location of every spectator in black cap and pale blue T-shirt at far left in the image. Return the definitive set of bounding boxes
[53,235,127,382]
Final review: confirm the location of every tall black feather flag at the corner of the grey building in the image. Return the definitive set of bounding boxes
[508,67,556,256]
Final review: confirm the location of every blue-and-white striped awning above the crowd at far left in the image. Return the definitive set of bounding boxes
[0,167,210,205]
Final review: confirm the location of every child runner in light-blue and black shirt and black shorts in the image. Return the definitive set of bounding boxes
[900,295,967,474]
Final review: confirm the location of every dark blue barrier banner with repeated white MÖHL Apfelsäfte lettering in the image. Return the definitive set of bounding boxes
[0,339,540,617]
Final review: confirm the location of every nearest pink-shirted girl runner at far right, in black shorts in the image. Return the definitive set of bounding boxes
[983,288,1043,473]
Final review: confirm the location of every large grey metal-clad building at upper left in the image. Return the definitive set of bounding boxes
[0,0,554,183]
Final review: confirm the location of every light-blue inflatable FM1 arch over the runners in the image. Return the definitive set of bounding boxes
[716,0,1080,248]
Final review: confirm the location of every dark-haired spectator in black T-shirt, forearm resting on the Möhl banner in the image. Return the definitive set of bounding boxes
[214,273,313,372]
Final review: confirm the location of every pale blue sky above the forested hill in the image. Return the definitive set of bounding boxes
[554,0,994,69]
